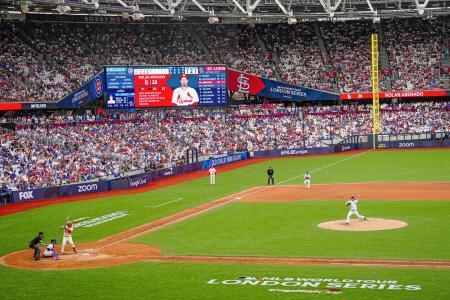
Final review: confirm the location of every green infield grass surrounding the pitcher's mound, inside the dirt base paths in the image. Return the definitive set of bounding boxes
[135,201,450,260]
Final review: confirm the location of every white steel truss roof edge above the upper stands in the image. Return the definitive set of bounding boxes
[0,0,450,23]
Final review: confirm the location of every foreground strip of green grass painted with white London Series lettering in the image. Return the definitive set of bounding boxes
[0,262,450,300]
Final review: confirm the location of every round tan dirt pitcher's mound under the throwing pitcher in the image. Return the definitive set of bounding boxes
[317,218,408,231]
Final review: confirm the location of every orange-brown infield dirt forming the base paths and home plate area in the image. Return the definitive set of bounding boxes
[0,182,450,270]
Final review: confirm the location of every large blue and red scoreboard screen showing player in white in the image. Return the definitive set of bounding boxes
[106,65,227,108]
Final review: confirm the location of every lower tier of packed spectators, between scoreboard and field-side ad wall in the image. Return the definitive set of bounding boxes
[0,101,450,191]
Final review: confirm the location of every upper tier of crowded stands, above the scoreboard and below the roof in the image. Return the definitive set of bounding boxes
[0,17,449,102]
